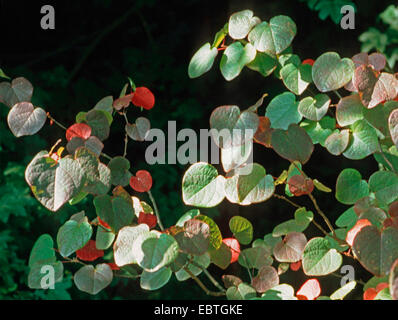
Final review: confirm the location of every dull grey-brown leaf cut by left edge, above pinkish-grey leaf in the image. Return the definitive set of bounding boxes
[0,77,33,108]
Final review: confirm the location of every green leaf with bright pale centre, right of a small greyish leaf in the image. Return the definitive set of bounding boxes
[343,120,379,160]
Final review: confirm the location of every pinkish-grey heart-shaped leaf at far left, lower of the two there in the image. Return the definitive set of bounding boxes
[7,102,47,138]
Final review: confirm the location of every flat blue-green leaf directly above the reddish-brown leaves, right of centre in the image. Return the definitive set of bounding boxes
[265,92,302,130]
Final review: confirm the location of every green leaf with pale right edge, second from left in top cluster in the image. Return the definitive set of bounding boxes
[220,42,256,81]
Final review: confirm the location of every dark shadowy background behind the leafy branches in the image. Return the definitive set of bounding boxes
[0,0,394,299]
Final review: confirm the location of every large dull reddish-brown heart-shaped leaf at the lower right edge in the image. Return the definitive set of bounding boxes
[352,226,398,276]
